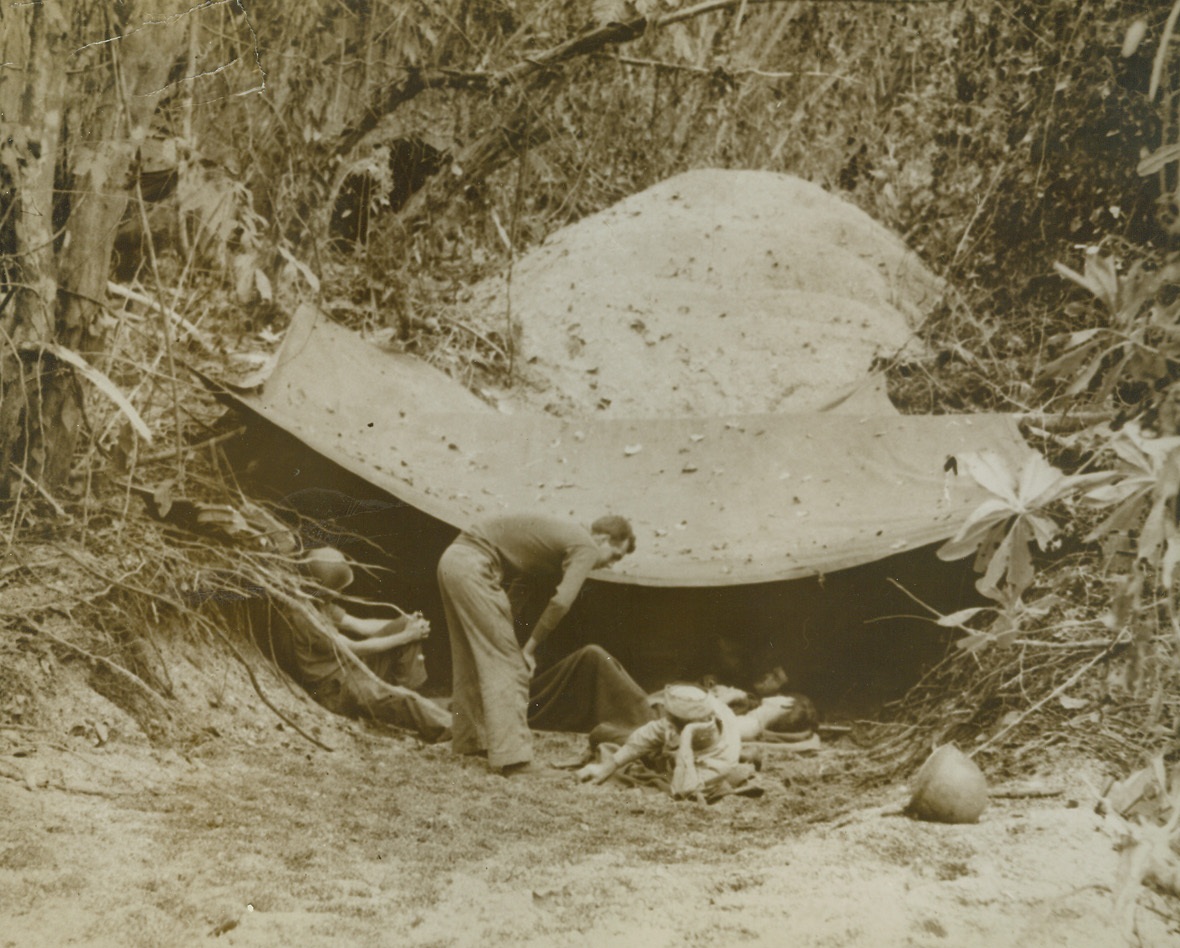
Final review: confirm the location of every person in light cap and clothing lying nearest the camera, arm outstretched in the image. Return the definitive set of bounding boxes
[577,685,758,803]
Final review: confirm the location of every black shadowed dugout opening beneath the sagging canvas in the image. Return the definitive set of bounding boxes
[219,416,978,718]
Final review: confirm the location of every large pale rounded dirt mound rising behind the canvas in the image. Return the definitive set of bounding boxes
[467,170,940,418]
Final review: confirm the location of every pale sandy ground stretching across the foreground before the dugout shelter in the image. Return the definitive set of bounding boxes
[0,715,1180,948]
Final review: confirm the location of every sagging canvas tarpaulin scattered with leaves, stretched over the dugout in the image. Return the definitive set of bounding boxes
[223,306,1030,587]
